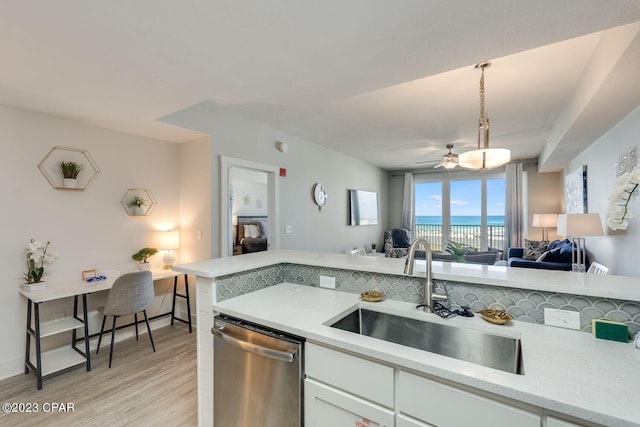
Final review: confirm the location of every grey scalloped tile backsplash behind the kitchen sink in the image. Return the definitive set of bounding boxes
[216,263,640,335]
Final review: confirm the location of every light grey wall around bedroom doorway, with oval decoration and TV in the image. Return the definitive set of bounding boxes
[163,103,388,257]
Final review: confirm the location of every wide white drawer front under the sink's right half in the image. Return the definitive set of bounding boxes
[398,371,540,427]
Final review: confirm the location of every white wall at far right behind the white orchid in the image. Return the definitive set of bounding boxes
[564,107,640,276]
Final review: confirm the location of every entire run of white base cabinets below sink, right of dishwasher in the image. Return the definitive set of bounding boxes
[304,342,552,427]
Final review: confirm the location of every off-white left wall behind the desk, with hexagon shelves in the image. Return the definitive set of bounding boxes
[0,106,180,378]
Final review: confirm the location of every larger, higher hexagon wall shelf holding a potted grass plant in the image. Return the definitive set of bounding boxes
[38,147,100,190]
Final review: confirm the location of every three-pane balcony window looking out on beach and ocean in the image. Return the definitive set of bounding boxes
[415,175,505,252]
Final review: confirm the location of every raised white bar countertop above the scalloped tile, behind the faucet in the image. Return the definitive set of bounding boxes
[173,249,640,301]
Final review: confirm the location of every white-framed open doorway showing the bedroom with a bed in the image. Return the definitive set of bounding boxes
[220,156,279,257]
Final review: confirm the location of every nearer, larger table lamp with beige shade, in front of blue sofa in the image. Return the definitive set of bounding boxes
[558,213,604,273]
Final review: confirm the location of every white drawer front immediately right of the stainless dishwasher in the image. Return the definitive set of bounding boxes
[305,343,394,408]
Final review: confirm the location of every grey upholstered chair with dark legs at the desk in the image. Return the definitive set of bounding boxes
[96,271,156,368]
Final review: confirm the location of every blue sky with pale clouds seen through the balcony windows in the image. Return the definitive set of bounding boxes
[415,179,505,216]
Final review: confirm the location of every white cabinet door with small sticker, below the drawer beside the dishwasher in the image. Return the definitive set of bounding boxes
[304,379,394,427]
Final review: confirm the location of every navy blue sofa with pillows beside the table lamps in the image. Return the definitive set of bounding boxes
[507,239,576,271]
